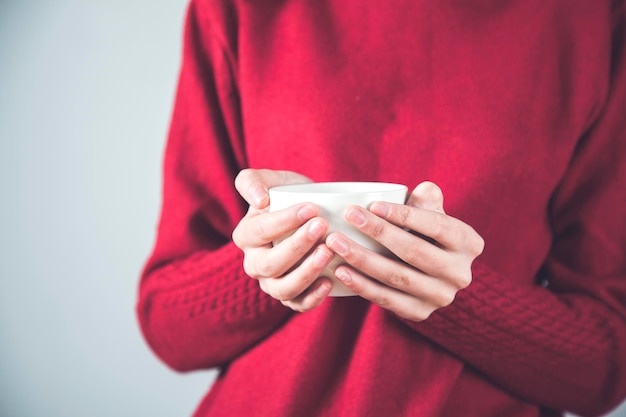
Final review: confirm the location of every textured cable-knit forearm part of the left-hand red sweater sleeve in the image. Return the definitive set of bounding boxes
[138,243,291,371]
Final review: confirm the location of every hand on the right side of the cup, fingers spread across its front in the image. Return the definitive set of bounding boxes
[326,182,484,321]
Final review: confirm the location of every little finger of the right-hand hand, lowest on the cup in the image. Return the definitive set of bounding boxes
[335,265,452,322]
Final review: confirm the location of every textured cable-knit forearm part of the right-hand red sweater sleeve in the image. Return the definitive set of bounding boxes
[404,261,625,410]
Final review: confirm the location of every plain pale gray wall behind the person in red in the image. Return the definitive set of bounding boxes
[0,0,626,417]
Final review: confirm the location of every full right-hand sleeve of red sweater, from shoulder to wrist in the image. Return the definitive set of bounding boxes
[409,2,626,415]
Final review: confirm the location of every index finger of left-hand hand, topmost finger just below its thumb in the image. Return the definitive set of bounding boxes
[232,203,319,249]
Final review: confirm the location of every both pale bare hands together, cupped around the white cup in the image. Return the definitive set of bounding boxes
[233,169,484,321]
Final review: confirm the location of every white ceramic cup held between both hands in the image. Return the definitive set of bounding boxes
[269,182,407,297]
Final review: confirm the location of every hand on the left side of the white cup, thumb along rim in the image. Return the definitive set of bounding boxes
[233,169,334,311]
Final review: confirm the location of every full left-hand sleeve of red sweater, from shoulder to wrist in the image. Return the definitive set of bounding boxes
[137,1,290,371]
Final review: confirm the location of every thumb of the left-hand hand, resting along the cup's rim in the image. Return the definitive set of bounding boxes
[235,169,312,209]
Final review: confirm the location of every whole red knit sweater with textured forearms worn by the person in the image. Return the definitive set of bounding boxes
[138,0,626,417]
